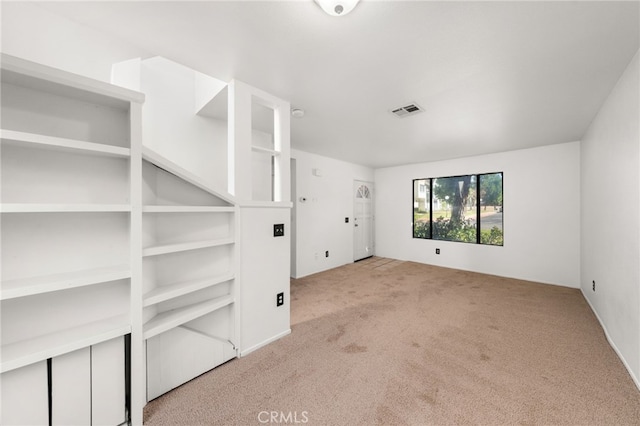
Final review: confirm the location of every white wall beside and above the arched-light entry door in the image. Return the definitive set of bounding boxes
[291,150,375,278]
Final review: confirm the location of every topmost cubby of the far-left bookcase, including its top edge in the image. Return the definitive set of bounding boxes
[2,55,144,148]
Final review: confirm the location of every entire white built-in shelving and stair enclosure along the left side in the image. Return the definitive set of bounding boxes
[0,54,291,425]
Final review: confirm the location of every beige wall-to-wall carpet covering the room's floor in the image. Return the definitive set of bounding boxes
[145,258,640,425]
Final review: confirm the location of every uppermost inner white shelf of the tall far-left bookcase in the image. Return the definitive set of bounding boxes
[0,129,131,158]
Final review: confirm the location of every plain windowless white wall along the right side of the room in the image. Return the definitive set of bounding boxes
[580,52,640,387]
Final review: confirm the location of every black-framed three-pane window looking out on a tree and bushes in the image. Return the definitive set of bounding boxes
[413,172,504,246]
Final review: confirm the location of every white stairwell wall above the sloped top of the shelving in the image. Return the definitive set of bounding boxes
[112,56,227,194]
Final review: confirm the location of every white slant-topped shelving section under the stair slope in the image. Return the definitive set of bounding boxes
[142,147,237,399]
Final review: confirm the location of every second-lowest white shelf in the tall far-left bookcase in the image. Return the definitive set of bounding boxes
[0,265,131,300]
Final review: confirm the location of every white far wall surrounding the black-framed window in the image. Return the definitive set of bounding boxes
[375,142,580,288]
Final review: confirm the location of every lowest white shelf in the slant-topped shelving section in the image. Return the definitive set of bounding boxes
[143,295,233,339]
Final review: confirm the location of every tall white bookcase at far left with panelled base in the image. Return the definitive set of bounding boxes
[0,55,144,424]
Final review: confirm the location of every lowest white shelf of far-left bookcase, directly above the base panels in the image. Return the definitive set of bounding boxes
[0,315,131,373]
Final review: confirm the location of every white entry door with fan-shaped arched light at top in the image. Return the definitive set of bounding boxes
[353,180,374,261]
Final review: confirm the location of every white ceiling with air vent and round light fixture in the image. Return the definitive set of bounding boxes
[38,0,640,167]
